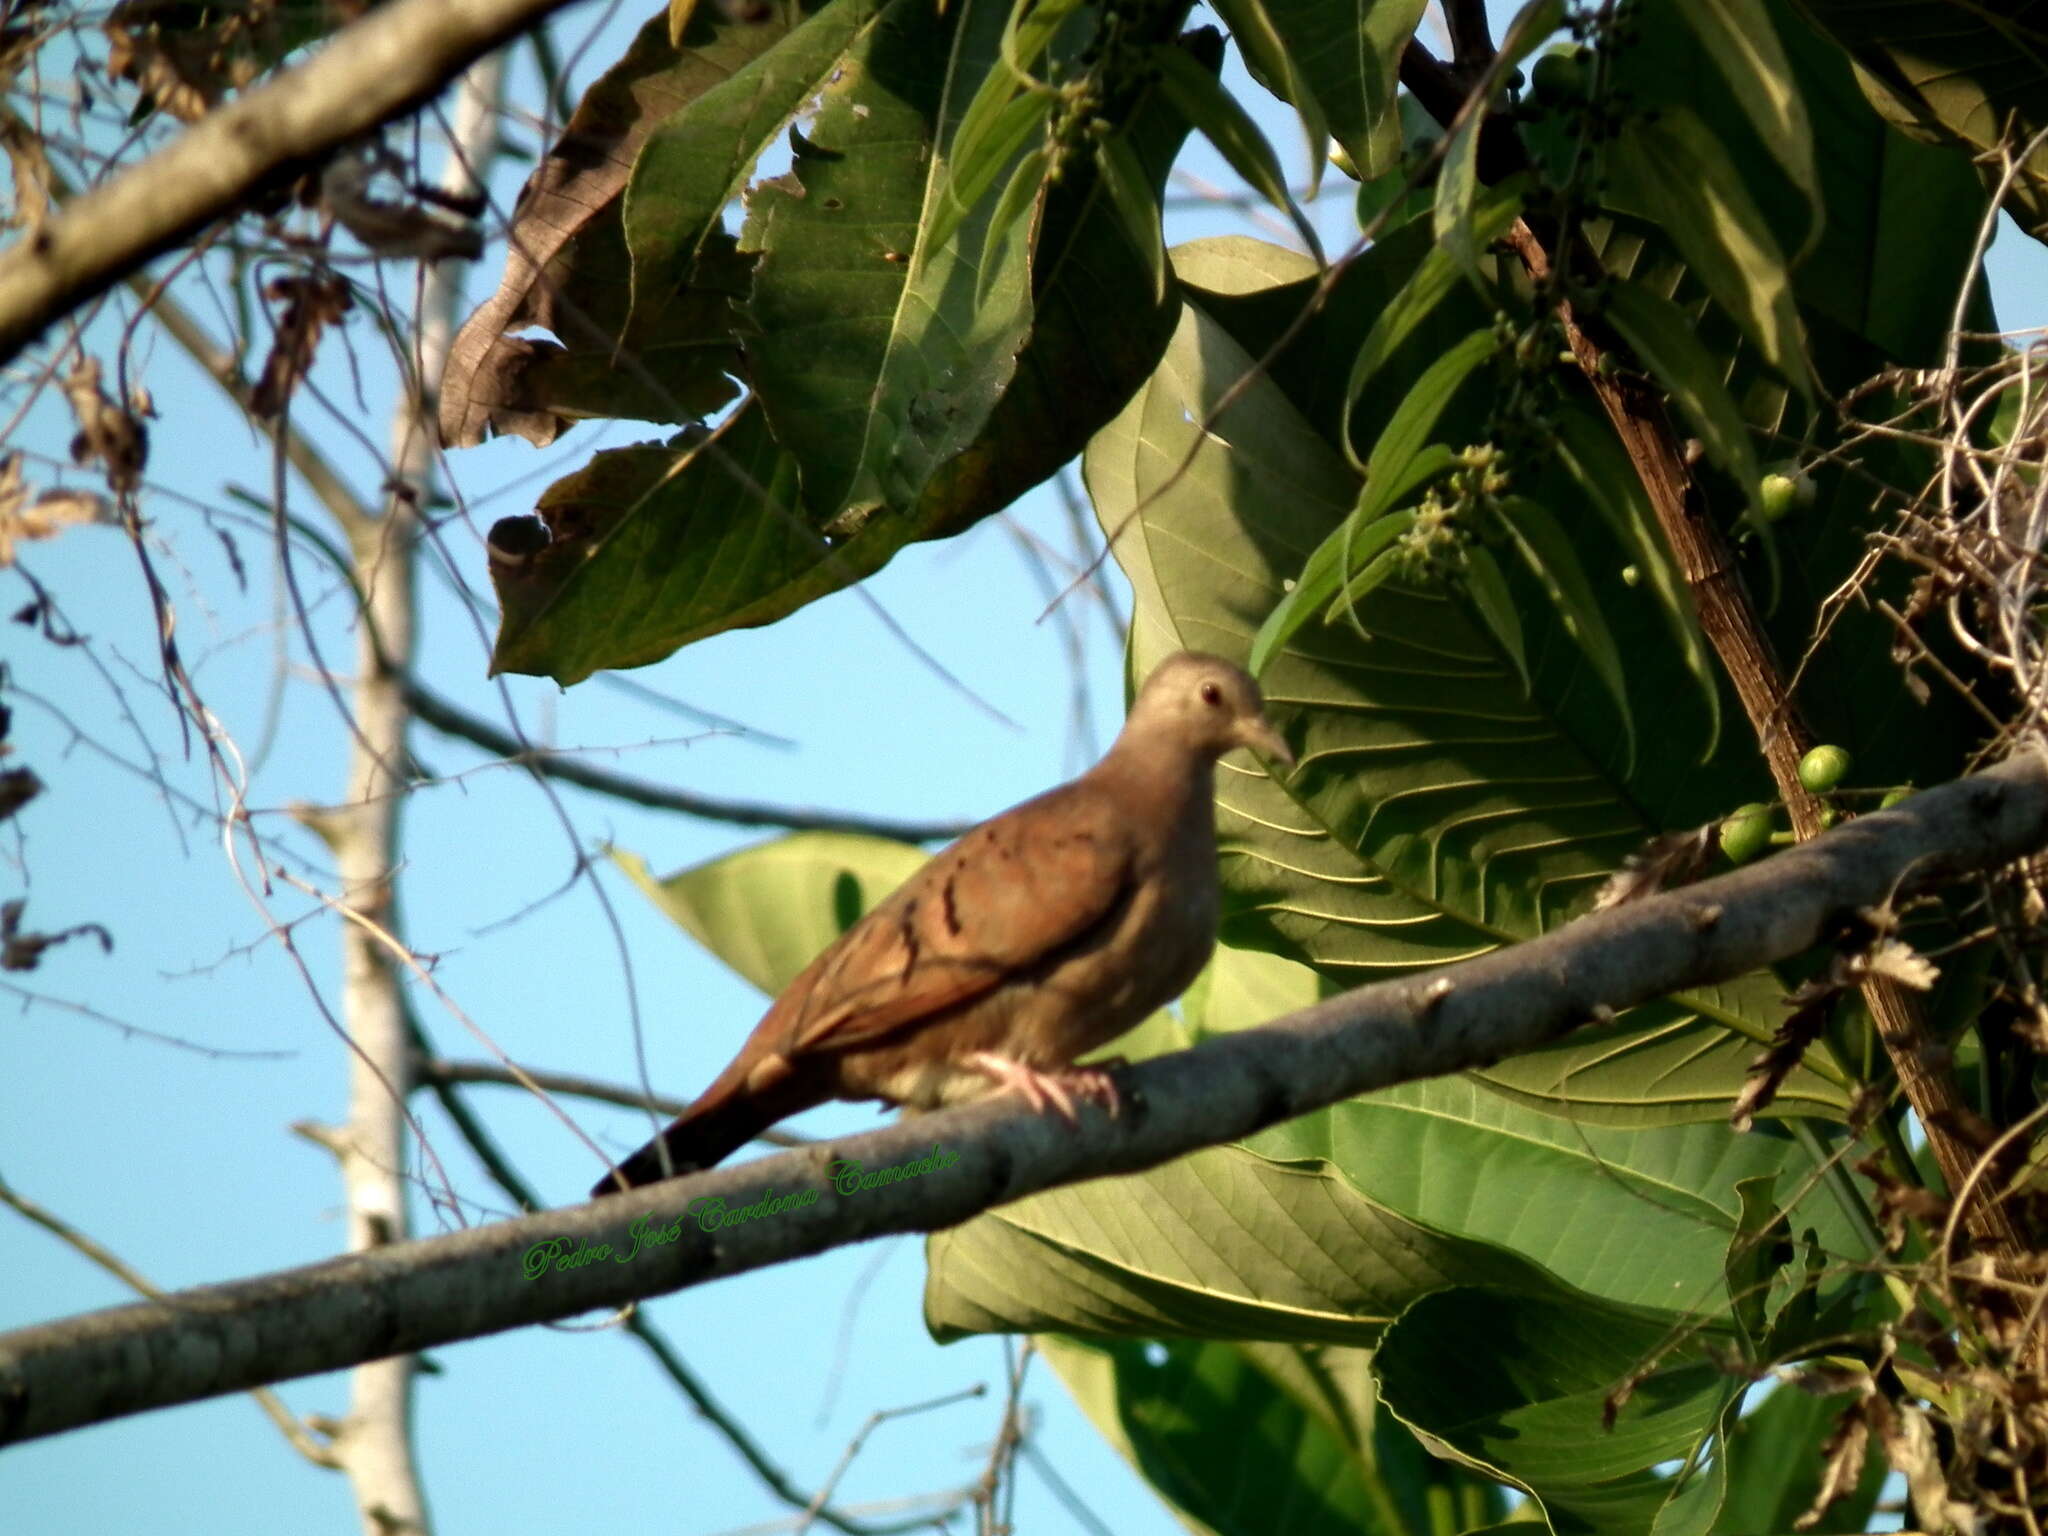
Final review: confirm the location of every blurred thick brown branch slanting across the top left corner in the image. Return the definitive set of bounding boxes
[0,0,567,365]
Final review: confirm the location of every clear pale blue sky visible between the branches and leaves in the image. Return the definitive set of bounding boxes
[0,8,2048,1536]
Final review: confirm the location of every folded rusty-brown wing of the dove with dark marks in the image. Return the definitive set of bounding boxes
[756,780,1135,1055]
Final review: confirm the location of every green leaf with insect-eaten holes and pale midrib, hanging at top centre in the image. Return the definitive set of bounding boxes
[739,0,1024,532]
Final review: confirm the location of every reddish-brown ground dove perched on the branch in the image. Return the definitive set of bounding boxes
[592,651,1294,1194]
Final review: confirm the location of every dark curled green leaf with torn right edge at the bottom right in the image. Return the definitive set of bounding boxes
[1376,1286,1726,1536]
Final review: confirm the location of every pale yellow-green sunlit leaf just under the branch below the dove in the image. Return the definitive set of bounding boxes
[924,1147,1536,1346]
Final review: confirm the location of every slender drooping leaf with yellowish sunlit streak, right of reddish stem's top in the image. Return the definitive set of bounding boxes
[1608,106,1810,393]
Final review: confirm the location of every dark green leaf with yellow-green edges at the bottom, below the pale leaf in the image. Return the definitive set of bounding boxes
[1038,1333,1507,1536]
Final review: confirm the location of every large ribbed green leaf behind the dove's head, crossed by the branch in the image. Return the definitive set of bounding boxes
[1085,282,1843,1124]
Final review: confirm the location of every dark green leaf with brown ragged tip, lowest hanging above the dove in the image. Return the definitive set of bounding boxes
[479,22,1196,684]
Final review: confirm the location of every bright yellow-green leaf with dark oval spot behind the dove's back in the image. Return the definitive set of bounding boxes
[606,831,928,997]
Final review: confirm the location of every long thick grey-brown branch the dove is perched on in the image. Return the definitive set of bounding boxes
[0,752,2048,1444]
